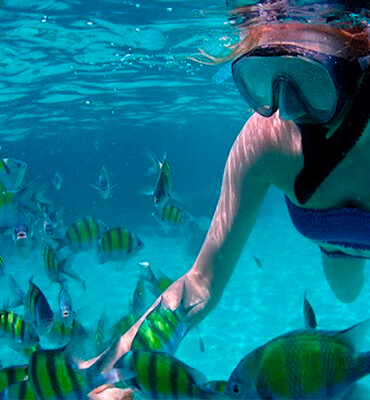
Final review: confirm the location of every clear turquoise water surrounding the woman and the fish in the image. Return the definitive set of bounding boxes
[0,0,370,398]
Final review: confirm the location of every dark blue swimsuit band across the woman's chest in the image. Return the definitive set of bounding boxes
[285,196,370,258]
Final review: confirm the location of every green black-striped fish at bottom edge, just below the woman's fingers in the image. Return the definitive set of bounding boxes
[114,350,214,400]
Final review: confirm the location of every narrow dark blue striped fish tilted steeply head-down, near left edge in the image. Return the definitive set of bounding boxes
[25,279,54,335]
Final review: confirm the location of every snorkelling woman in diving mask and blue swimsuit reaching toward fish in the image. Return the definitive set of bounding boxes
[94,0,370,399]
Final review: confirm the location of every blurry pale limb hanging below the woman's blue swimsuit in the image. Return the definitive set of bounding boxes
[321,252,365,303]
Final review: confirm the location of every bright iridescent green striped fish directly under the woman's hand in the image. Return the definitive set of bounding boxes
[131,290,195,354]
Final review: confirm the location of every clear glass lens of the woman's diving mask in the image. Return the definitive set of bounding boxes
[232,55,338,123]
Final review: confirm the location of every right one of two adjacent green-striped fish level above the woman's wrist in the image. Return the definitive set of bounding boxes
[98,228,143,264]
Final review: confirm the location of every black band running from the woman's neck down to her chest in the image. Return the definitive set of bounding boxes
[294,69,370,204]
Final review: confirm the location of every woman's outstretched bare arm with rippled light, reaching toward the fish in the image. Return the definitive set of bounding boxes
[89,114,300,396]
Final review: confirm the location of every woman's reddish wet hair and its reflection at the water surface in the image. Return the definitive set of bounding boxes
[229,0,370,59]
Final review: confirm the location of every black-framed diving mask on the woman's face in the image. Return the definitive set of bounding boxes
[231,45,369,124]
